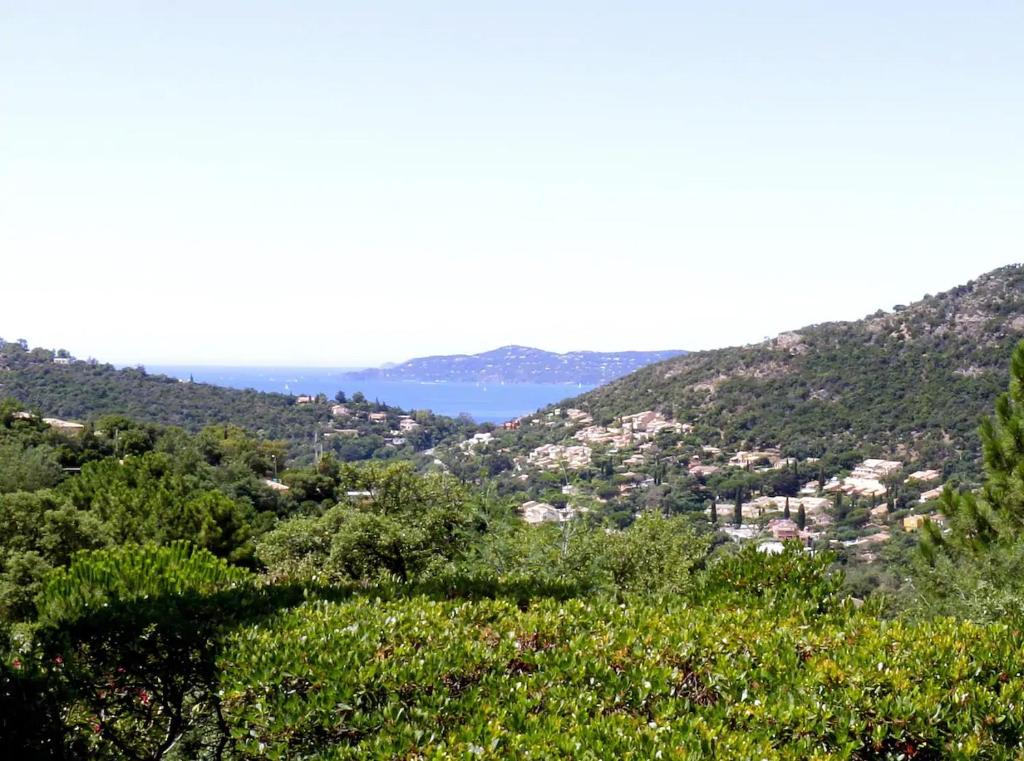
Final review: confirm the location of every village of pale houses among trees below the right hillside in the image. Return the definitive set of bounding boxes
[444,408,945,562]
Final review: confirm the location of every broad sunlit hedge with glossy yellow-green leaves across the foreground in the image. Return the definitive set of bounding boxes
[219,581,1024,759]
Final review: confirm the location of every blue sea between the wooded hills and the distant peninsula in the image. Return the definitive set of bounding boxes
[145,365,594,423]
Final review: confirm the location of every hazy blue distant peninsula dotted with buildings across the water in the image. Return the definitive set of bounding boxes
[344,346,686,386]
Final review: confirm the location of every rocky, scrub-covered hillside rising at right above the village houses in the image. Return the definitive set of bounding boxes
[571,264,1024,467]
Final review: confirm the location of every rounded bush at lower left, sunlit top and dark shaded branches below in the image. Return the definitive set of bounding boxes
[35,543,255,759]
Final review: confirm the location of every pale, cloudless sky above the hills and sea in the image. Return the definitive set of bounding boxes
[0,0,1024,367]
